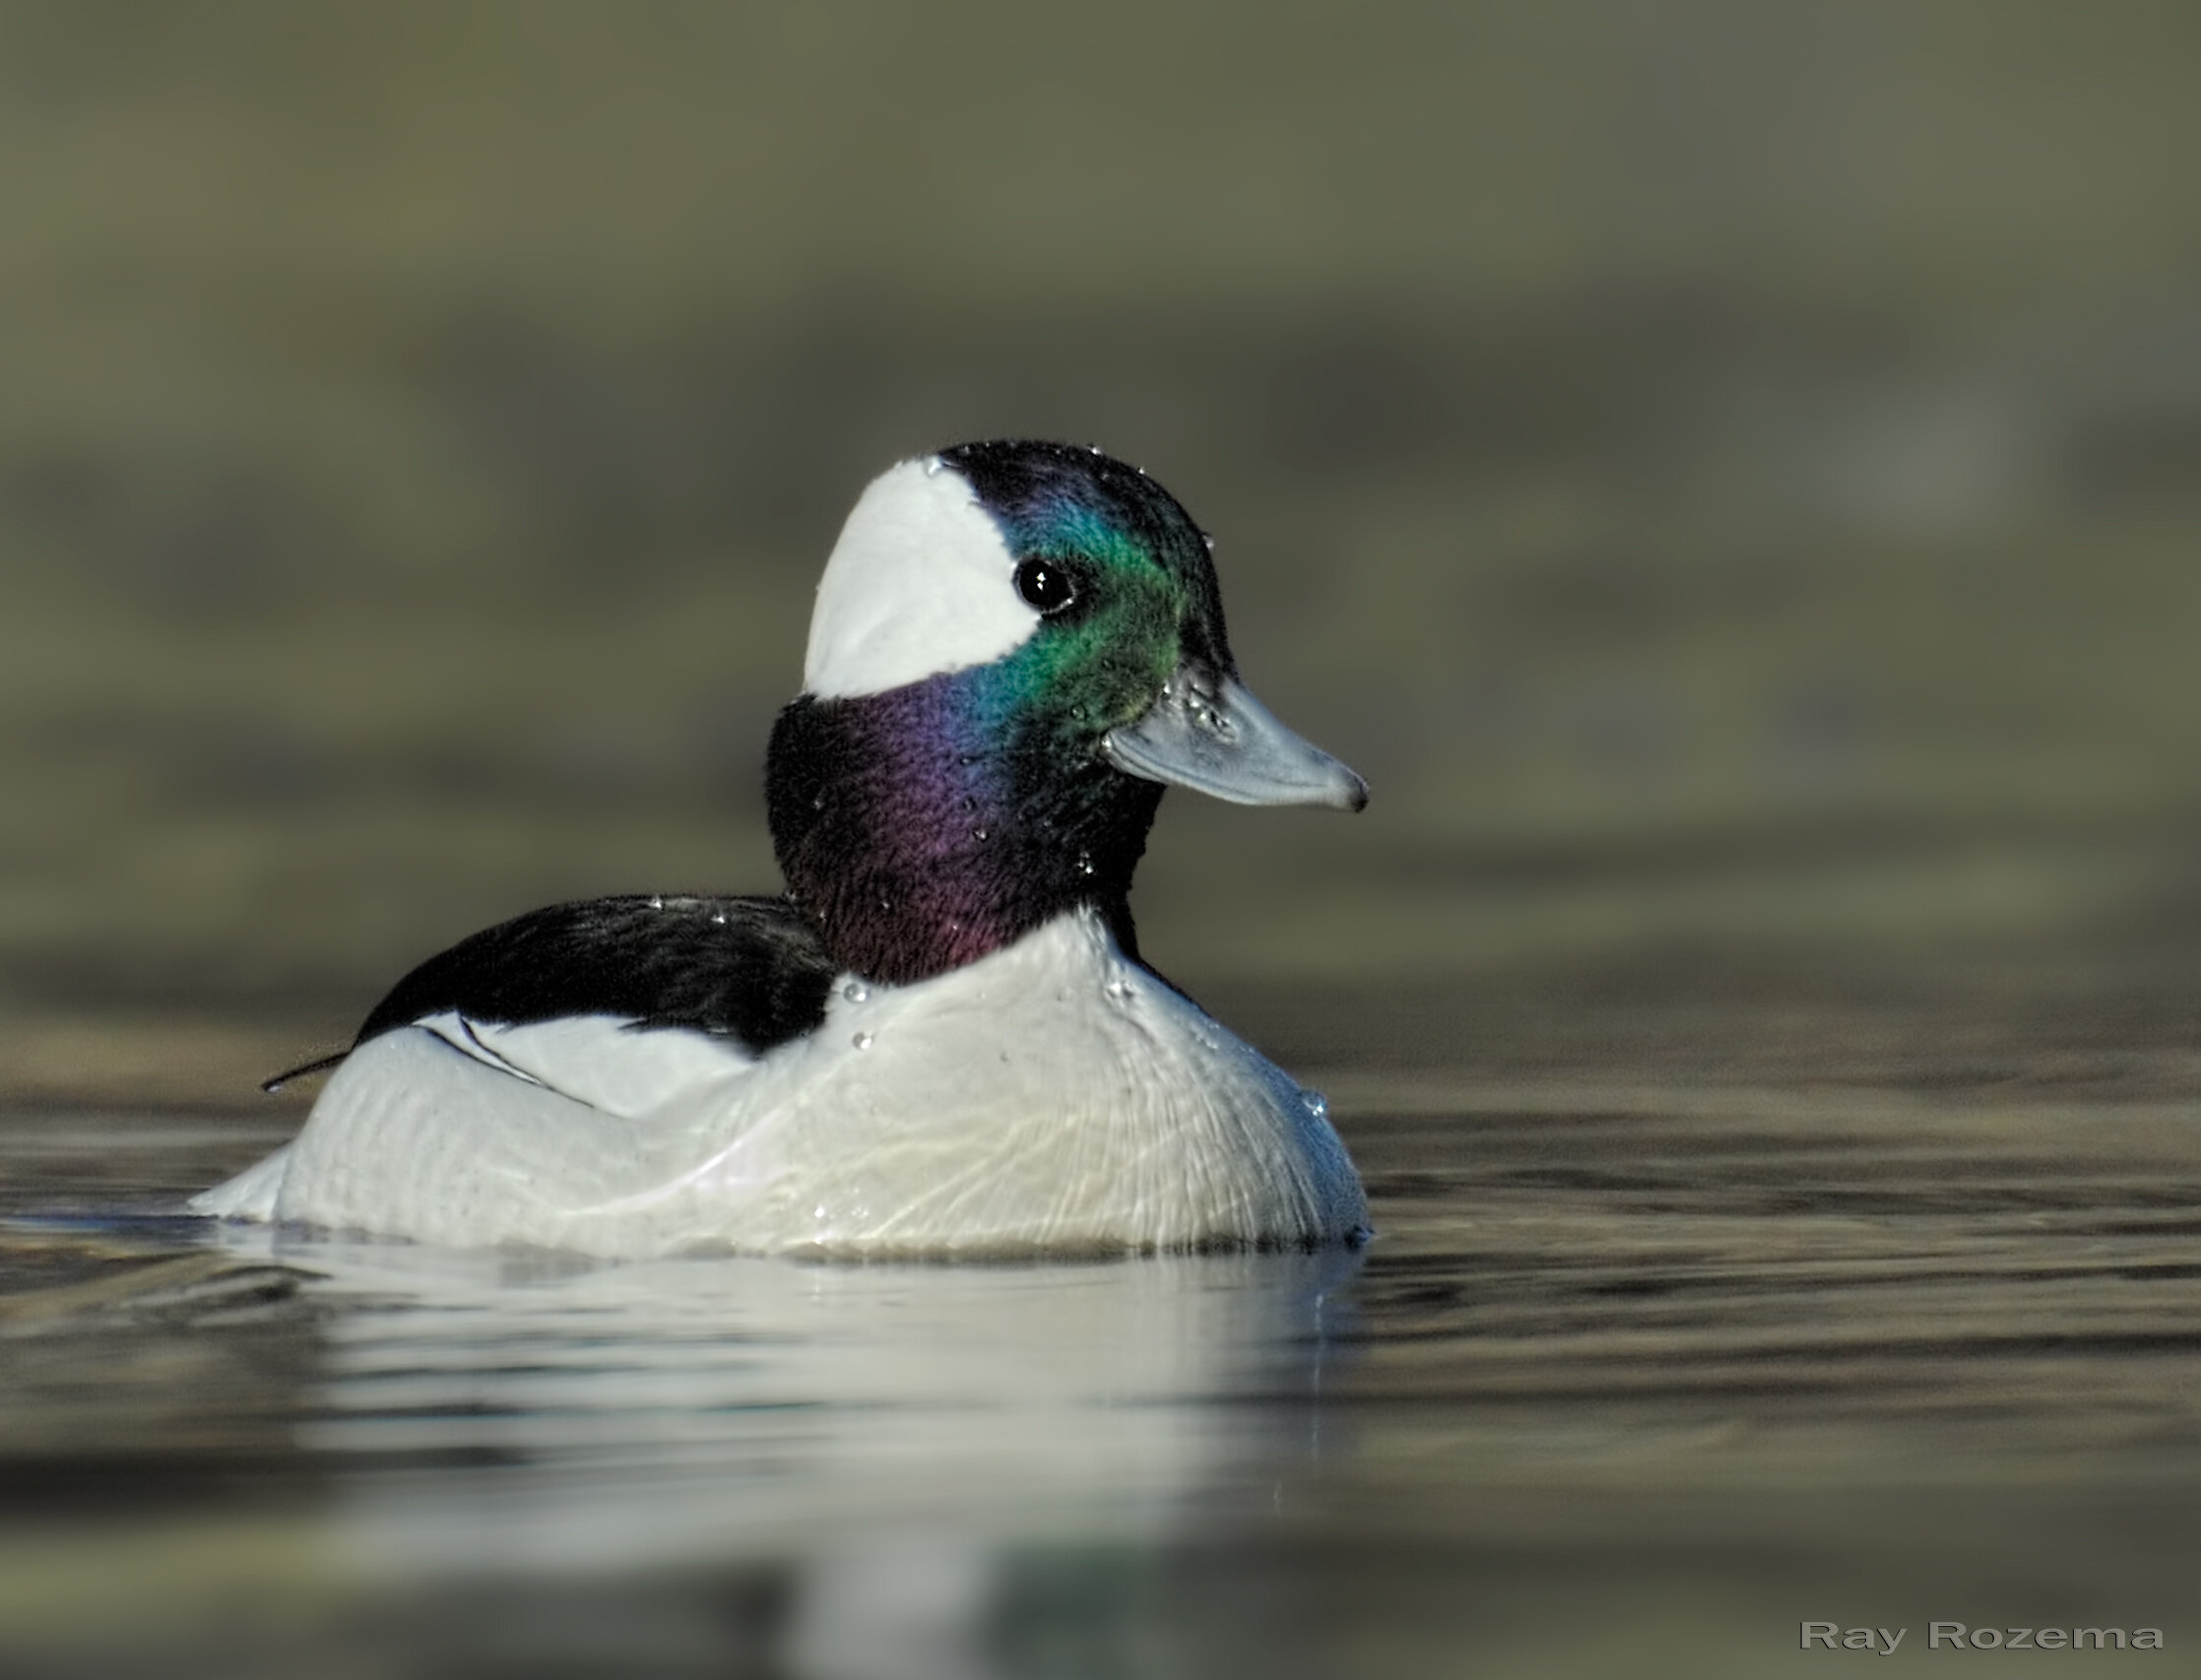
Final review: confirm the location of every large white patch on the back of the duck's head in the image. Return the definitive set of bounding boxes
[804,456,1039,698]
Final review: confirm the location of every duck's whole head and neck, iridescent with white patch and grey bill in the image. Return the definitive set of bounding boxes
[766,442,1367,984]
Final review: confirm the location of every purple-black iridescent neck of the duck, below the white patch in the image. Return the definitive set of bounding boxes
[766,667,1162,984]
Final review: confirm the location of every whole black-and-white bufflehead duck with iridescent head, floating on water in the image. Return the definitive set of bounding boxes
[207,442,1367,1255]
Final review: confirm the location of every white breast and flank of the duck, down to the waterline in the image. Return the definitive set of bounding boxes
[200,912,1367,1255]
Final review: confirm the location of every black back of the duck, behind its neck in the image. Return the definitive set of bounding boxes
[355,894,834,1055]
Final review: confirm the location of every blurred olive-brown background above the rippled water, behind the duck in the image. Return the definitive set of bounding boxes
[0,0,2201,1103]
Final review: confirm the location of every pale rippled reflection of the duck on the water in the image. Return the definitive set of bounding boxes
[221,1226,1360,1680]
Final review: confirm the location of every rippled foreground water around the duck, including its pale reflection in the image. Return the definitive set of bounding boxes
[0,1043,2201,1678]
